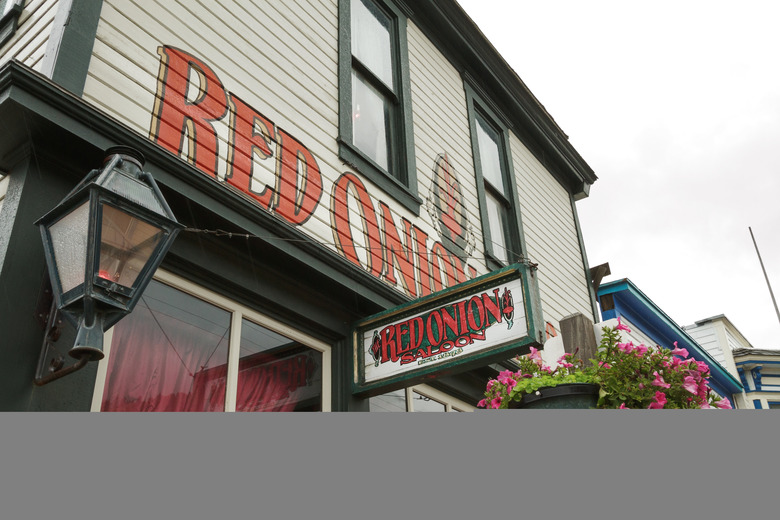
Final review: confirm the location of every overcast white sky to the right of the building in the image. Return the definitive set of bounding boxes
[458,0,780,349]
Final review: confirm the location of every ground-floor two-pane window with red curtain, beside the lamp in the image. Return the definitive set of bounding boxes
[101,280,322,412]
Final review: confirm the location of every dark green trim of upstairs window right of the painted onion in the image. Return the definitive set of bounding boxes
[464,79,526,269]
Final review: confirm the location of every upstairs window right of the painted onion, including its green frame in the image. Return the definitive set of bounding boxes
[466,84,525,268]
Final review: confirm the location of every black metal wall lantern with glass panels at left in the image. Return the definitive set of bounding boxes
[36,146,183,384]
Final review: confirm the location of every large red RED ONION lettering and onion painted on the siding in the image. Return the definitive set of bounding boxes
[149,46,477,298]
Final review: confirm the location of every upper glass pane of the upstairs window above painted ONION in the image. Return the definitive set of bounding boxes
[351,0,394,90]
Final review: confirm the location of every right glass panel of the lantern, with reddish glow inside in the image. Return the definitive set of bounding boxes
[98,204,164,287]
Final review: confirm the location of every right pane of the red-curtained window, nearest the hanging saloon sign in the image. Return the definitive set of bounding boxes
[236,320,322,412]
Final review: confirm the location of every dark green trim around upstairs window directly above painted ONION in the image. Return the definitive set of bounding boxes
[338,0,422,215]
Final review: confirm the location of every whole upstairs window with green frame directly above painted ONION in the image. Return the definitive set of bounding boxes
[339,0,421,212]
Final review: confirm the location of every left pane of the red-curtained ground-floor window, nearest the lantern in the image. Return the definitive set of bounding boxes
[102,280,230,412]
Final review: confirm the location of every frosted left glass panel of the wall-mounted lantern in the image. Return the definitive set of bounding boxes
[49,201,89,293]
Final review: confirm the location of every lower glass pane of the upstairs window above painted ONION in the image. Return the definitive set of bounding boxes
[352,72,390,171]
